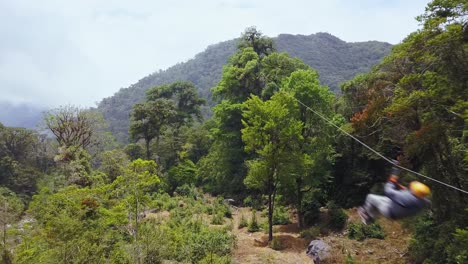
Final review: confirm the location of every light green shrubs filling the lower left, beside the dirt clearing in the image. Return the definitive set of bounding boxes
[15,165,235,263]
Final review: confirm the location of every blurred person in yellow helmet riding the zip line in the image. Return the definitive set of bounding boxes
[358,159,431,225]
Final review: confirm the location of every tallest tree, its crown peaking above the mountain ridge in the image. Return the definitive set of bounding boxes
[200,28,310,194]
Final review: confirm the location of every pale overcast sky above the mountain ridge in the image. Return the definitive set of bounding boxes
[0,0,429,107]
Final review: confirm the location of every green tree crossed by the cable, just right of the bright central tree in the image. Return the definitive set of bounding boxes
[283,69,338,227]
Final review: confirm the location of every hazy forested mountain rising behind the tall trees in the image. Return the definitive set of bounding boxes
[98,33,392,142]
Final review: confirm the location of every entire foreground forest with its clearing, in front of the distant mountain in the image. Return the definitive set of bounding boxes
[0,0,468,264]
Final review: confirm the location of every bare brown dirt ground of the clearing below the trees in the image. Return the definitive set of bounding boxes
[232,208,410,264]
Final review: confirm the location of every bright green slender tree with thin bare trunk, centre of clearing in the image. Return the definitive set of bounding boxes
[242,92,303,241]
